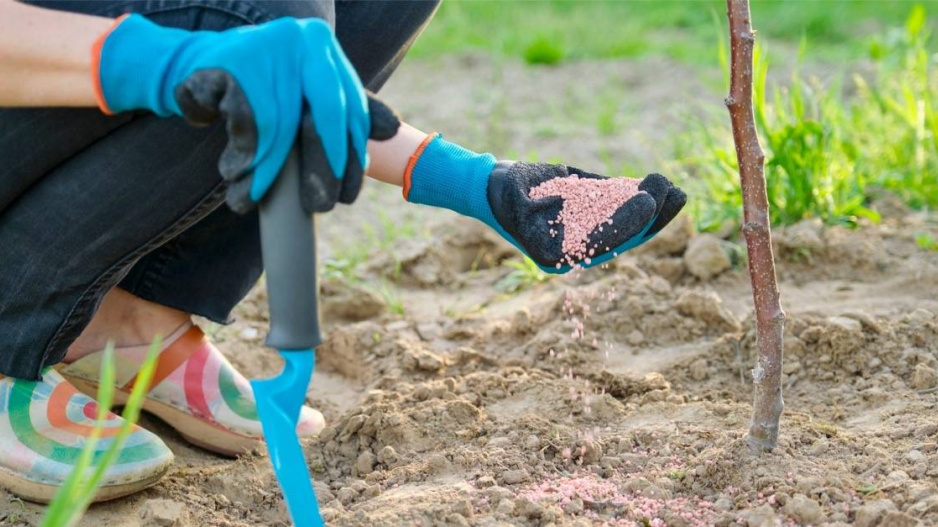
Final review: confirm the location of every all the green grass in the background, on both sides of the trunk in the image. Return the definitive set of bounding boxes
[413,0,938,233]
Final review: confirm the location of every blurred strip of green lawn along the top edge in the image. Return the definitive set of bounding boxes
[412,0,928,65]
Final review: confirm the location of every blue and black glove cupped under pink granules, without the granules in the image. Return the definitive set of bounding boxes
[404,136,686,273]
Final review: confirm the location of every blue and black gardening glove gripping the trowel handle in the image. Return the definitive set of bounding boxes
[95,15,371,212]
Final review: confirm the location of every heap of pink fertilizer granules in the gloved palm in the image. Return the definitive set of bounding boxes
[528,174,641,267]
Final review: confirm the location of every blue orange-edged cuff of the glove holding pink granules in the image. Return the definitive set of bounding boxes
[404,134,495,223]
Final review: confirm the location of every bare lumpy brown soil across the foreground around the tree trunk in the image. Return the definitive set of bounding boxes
[0,57,938,527]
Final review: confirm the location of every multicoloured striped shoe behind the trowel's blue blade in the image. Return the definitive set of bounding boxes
[59,324,325,456]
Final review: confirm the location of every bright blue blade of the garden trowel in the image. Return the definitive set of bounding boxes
[251,350,325,527]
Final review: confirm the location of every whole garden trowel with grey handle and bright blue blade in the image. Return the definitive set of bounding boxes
[251,95,400,527]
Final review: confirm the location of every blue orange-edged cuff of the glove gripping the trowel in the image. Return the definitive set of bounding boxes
[91,15,190,117]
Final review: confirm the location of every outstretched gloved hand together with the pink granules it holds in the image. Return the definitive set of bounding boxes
[404,135,686,273]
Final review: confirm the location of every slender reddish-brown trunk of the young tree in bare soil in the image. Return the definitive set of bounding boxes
[726,0,785,452]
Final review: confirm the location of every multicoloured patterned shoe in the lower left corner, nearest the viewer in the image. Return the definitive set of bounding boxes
[0,369,173,503]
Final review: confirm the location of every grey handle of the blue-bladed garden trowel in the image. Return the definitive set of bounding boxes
[260,145,322,350]
